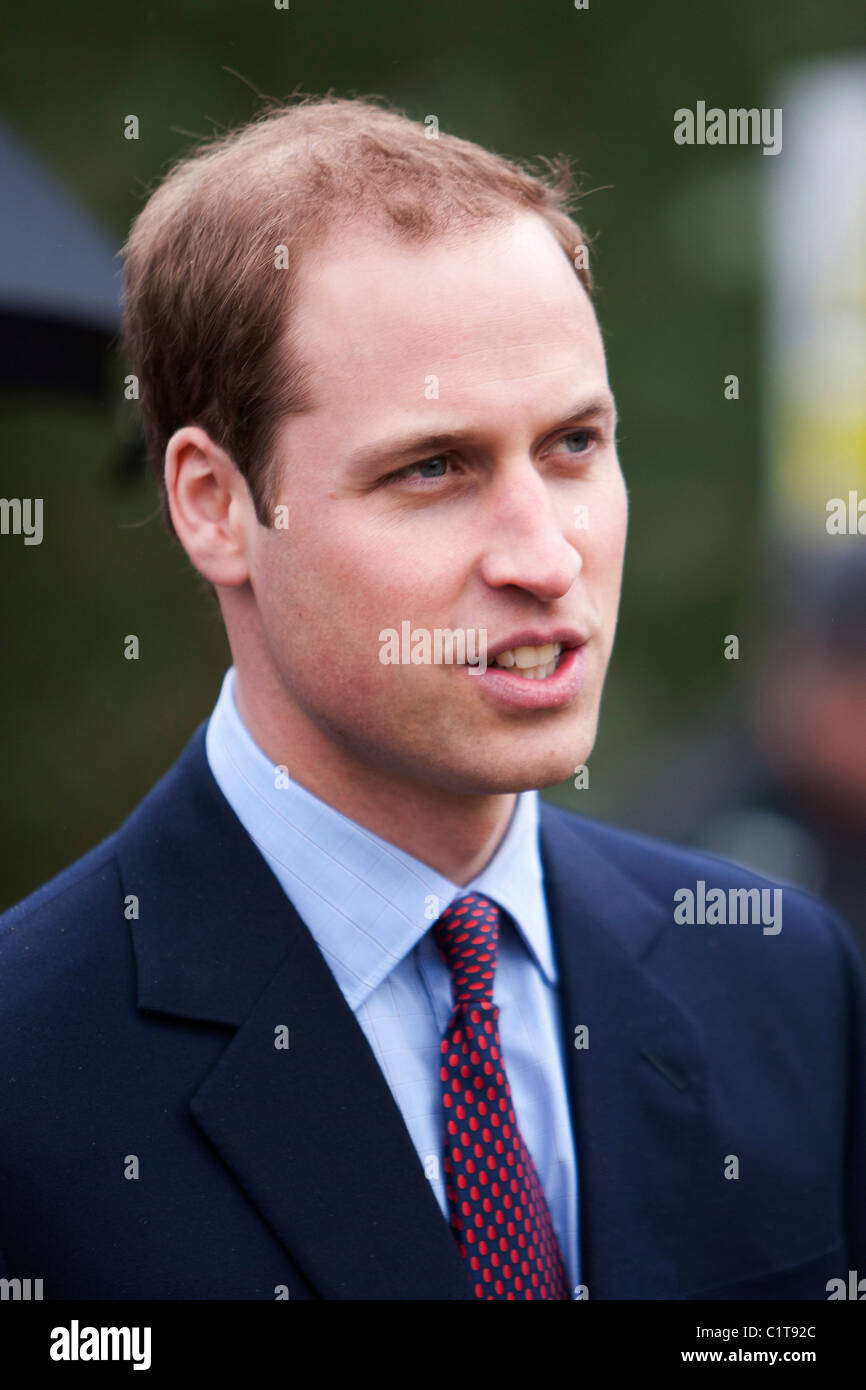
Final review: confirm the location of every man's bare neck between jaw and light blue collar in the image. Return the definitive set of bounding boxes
[235,670,517,887]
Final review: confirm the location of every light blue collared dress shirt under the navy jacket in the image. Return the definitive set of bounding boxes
[206,666,580,1287]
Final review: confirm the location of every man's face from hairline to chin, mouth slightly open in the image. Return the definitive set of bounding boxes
[244,214,627,794]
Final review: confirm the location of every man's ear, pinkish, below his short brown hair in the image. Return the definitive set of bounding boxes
[165,425,257,587]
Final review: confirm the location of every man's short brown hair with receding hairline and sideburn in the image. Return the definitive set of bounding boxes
[124,95,592,527]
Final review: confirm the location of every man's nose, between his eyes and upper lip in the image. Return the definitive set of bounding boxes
[481,459,584,600]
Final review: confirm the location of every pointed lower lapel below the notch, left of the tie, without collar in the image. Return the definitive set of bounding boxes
[192,929,471,1300]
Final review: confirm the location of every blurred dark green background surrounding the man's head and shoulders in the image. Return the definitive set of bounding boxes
[0,0,866,945]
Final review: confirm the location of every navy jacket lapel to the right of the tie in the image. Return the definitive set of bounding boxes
[541,805,706,1300]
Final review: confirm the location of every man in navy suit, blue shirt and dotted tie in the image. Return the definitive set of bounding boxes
[0,99,866,1300]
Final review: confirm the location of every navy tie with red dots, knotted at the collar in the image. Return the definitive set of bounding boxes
[434,892,569,1298]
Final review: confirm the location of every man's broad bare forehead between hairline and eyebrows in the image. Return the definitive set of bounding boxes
[287,214,606,403]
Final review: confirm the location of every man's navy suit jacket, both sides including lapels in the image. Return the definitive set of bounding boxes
[0,726,866,1300]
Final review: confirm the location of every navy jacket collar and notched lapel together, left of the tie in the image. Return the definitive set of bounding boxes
[118,726,474,1300]
